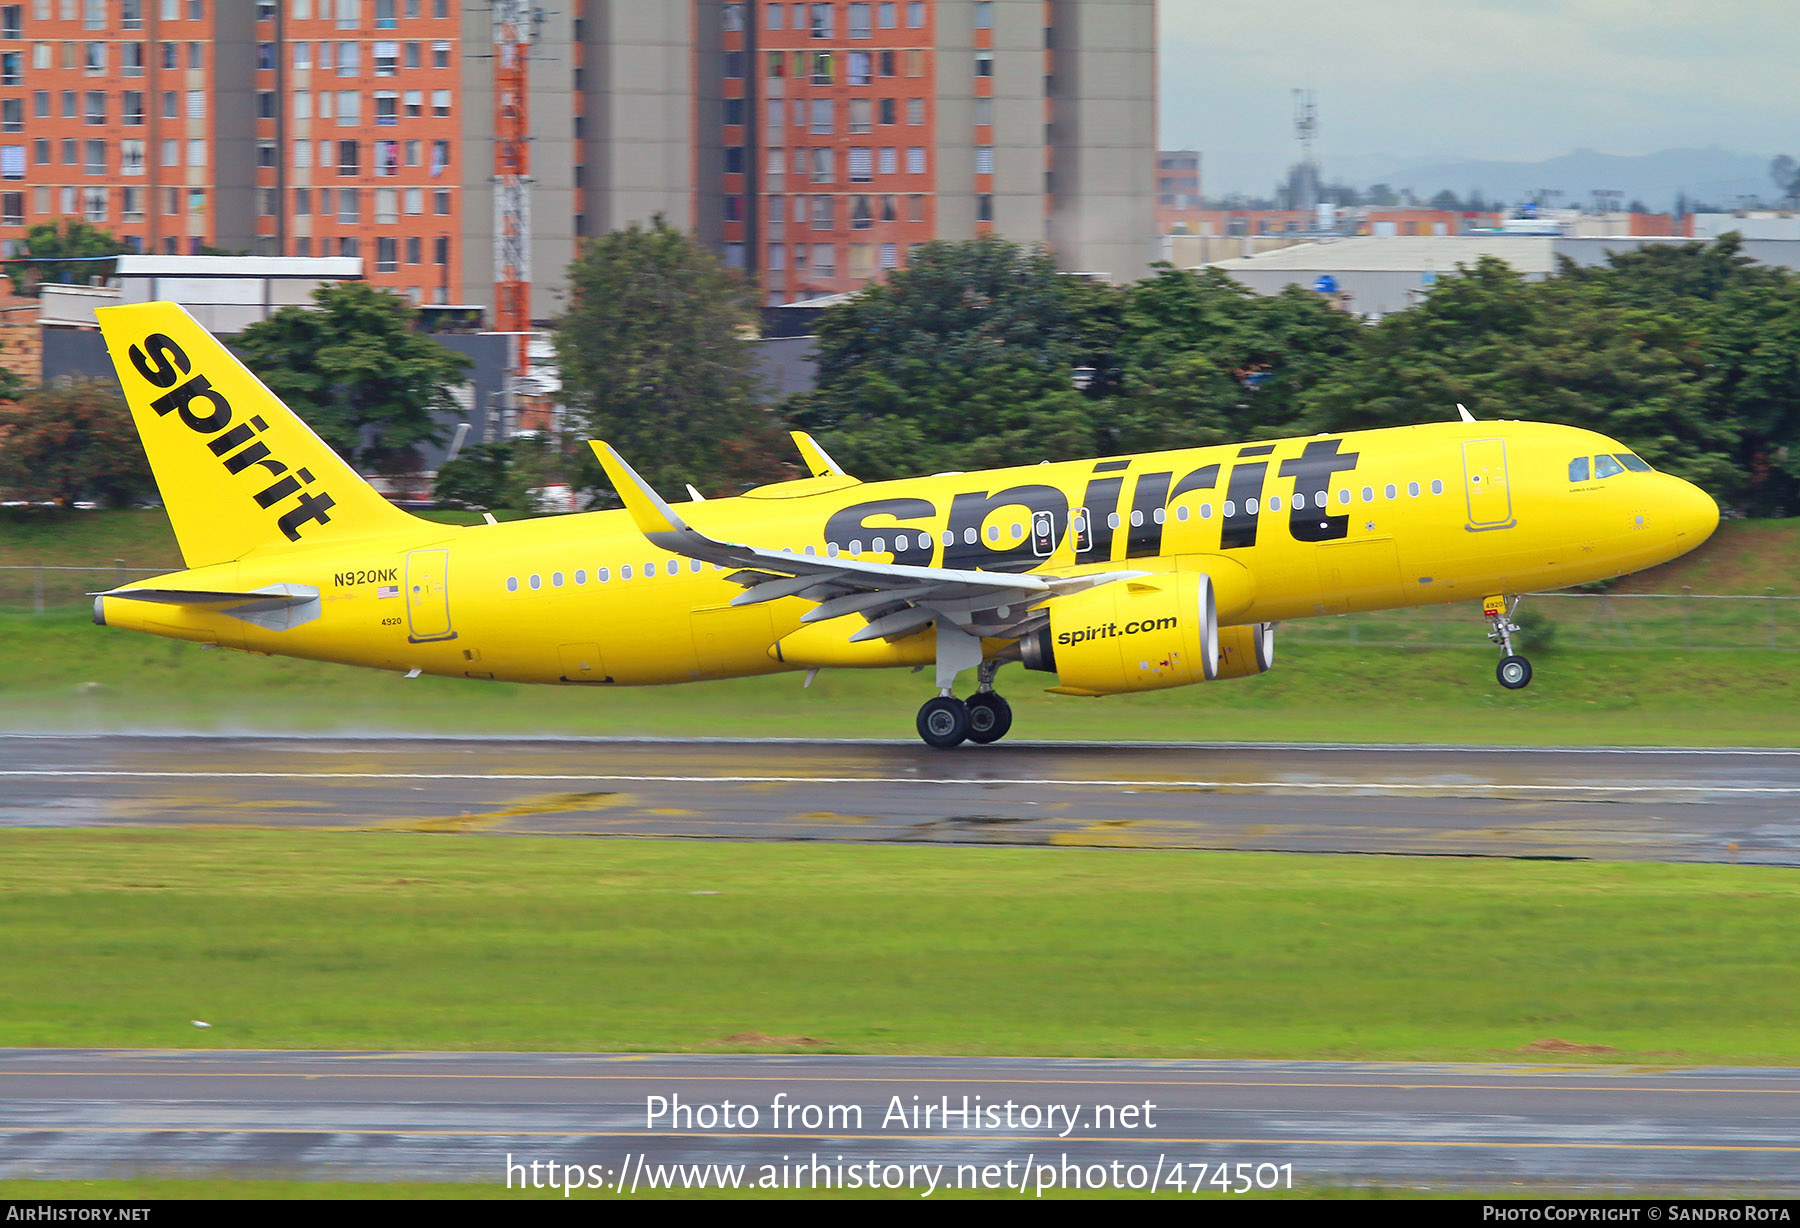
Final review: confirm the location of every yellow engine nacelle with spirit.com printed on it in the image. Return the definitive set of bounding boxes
[1019,571,1219,695]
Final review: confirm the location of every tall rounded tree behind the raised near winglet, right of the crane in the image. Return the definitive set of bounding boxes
[556,216,785,490]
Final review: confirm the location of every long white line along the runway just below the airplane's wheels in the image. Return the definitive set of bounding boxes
[0,767,1800,796]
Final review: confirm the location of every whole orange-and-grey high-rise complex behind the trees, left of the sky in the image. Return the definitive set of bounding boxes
[0,0,1156,319]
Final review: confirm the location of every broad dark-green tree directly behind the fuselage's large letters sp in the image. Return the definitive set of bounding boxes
[788,236,1123,479]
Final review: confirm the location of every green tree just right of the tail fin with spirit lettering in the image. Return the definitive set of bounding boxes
[236,281,468,472]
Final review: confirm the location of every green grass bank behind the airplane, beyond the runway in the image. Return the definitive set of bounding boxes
[0,510,1800,745]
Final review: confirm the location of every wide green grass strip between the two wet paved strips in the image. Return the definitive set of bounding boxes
[10,830,1800,1064]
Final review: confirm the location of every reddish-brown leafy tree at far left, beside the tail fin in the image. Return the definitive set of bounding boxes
[0,380,155,506]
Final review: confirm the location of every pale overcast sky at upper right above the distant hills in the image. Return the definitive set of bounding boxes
[1159,0,1800,194]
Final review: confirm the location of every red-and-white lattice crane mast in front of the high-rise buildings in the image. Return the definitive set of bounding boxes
[491,0,542,380]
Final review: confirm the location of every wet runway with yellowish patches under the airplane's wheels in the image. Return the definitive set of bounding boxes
[0,735,1800,866]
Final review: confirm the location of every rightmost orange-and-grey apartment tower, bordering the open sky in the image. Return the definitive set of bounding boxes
[720,0,1156,304]
